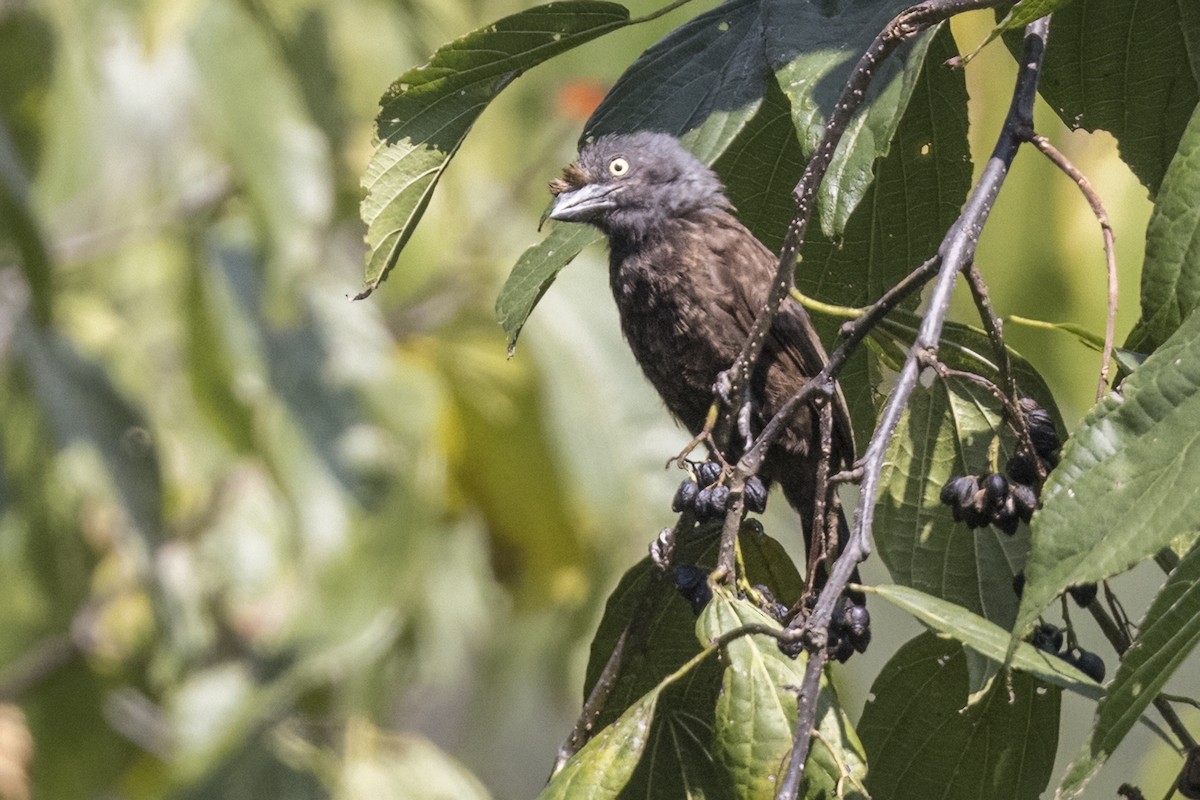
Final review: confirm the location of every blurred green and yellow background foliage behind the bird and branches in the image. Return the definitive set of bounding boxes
[0,0,1200,799]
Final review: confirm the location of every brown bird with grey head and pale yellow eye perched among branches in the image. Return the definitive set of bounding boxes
[547,131,865,646]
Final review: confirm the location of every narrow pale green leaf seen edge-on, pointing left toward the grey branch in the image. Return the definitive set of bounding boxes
[863,584,1100,699]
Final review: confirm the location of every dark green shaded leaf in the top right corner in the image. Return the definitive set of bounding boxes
[1032,0,1200,193]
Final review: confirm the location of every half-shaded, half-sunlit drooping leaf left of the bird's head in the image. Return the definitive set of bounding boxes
[359,0,630,297]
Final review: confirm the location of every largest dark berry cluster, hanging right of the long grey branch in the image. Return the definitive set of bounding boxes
[941,397,1061,536]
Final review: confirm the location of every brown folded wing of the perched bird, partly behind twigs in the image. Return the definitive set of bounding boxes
[706,213,854,465]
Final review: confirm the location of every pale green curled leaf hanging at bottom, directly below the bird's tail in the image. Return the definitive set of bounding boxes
[696,590,866,800]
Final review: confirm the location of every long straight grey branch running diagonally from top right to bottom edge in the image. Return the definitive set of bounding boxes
[776,12,1049,800]
